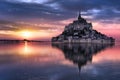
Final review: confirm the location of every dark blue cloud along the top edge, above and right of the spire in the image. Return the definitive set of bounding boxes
[51,0,120,11]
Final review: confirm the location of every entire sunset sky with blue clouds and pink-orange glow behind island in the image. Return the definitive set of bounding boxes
[0,0,120,40]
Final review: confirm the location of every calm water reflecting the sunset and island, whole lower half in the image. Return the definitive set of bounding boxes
[0,42,120,80]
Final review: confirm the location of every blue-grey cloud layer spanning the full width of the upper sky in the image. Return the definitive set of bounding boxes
[0,0,120,21]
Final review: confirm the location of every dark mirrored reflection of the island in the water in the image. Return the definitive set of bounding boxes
[52,43,114,71]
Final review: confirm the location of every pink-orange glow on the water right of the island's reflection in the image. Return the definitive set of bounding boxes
[93,47,120,63]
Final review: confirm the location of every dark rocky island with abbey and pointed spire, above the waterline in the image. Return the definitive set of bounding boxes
[52,13,115,43]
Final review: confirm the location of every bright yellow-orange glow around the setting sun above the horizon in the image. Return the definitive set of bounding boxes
[14,30,60,40]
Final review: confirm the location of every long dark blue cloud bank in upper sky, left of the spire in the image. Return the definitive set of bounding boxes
[0,1,75,21]
